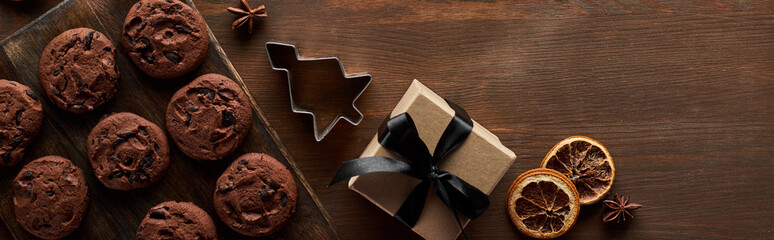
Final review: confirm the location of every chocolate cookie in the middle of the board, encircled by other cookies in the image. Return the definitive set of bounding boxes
[86,112,169,190]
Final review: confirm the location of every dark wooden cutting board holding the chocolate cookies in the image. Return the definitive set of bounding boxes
[0,0,341,239]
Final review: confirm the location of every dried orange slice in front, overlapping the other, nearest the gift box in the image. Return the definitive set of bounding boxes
[506,168,580,239]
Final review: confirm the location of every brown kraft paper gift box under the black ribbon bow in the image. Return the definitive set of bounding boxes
[349,80,516,240]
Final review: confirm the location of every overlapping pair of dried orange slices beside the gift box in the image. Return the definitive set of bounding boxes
[506,136,615,239]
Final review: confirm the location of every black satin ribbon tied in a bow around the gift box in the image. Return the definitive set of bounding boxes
[328,100,489,238]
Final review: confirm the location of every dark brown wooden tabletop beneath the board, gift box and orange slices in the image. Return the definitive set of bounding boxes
[0,0,774,239]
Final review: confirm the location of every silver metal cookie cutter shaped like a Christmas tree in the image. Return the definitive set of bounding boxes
[266,42,371,142]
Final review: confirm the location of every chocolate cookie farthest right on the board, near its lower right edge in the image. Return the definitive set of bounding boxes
[213,153,296,237]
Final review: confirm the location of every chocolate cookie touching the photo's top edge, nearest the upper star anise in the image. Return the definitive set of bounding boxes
[121,0,210,79]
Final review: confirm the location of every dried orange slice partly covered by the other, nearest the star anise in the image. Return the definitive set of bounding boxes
[540,136,615,205]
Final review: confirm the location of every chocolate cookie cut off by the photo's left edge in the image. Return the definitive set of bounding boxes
[0,79,43,167]
